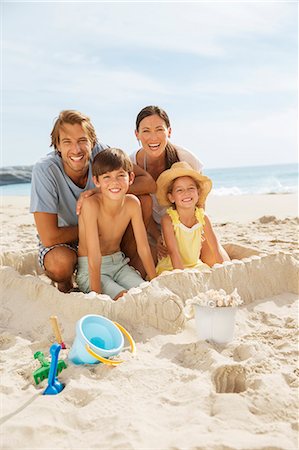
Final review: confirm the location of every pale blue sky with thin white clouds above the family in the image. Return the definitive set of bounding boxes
[0,0,298,168]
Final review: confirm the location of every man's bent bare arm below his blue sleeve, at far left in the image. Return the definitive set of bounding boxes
[34,212,78,247]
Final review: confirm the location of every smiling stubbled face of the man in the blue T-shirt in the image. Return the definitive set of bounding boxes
[57,123,92,179]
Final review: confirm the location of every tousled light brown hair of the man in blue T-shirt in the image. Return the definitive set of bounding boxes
[51,109,98,151]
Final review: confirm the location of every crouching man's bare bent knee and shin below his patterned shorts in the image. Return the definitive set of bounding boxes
[43,246,77,292]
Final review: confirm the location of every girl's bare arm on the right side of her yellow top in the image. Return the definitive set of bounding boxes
[200,215,230,267]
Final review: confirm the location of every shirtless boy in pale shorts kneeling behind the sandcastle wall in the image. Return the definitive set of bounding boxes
[77,148,156,300]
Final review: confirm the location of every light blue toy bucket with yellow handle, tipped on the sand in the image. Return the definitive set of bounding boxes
[68,314,136,366]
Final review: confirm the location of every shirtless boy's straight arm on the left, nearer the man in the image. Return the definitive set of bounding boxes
[79,198,102,294]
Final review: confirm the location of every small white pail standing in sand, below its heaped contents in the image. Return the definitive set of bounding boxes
[194,305,237,344]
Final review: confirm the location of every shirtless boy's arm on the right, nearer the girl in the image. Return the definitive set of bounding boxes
[128,196,156,280]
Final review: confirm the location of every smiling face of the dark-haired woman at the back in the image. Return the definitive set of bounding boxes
[135,114,171,158]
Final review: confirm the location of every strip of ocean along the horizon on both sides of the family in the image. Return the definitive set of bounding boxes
[0,164,298,196]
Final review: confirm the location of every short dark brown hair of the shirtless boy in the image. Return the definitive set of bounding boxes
[92,148,133,177]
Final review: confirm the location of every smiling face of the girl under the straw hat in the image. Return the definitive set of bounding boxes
[168,177,199,209]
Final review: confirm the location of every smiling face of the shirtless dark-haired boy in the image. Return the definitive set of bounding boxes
[93,168,134,200]
